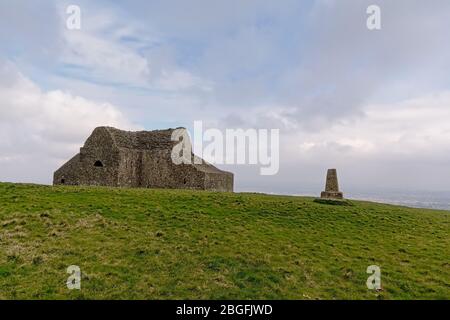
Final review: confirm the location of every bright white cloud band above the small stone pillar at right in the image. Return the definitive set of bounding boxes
[294,91,450,157]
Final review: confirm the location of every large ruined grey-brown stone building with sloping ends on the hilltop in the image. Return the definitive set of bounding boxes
[53,127,233,192]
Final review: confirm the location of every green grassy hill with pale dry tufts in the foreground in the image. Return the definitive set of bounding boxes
[0,183,450,299]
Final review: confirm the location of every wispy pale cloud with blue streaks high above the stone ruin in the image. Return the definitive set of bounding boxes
[59,2,212,91]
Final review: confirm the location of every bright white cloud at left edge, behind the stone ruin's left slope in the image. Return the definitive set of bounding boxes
[0,63,136,183]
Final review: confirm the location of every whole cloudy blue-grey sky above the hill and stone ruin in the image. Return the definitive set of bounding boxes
[0,0,450,194]
